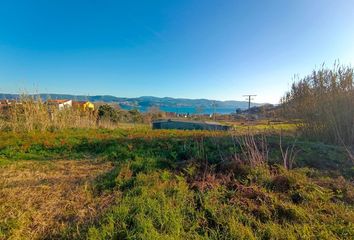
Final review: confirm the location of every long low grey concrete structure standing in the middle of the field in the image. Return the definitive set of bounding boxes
[152,119,230,131]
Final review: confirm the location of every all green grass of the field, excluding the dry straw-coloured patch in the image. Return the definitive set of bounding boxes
[0,127,354,239]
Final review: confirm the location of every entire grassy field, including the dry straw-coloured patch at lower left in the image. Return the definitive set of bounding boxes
[0,125,354,239]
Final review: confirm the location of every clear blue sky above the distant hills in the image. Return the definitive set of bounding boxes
[0,0,354,103]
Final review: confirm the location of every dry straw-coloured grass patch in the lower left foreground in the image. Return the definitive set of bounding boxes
[0,160,114,239]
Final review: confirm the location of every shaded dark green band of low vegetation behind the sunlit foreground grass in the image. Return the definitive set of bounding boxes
[0,135,354,177]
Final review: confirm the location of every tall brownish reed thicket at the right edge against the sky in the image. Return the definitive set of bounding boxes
[282,64,354,145]
